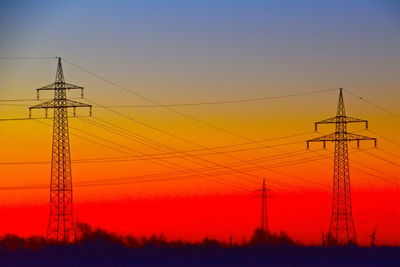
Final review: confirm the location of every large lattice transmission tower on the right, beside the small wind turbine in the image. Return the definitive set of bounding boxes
[307,88,376,245]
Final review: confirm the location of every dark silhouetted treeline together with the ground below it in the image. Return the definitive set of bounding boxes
[0,224,400,266]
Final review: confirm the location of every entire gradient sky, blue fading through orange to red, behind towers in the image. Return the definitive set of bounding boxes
[0,0,400,247]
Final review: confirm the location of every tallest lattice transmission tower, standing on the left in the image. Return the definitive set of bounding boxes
[29,57,92,243]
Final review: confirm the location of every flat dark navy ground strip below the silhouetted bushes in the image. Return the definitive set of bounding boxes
[0,242,400,266]
